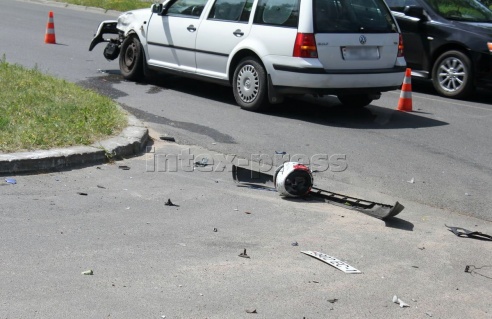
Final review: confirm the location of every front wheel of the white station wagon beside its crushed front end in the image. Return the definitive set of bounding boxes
[120,35,143,81]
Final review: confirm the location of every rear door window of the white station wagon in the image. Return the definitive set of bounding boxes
[208,0,253,22]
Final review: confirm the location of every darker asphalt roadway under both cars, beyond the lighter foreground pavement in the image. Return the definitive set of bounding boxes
[0,0,492,221]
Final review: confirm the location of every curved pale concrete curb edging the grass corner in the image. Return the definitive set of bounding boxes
[0,114,149,175]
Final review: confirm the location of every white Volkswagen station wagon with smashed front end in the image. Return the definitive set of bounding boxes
[89,0,406,111]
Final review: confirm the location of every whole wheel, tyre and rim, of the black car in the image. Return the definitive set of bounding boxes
[432,50,474,99]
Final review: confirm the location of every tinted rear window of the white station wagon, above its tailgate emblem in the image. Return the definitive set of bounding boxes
[313,0,398,33]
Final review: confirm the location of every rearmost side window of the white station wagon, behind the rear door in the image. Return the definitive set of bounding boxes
[253,0,299,27]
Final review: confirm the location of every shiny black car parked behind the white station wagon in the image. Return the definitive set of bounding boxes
[386,0,492,98]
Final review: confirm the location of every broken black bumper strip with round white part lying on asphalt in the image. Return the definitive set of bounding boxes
[232,162,405,220]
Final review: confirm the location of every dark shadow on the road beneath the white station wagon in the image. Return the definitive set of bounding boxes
[86,70,448,129]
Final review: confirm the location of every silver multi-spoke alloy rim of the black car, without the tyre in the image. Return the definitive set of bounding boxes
[438,57,466,92]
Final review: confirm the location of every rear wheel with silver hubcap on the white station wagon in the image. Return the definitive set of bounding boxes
[232,57,268,111]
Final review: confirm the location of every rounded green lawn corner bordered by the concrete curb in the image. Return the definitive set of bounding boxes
[0,56,127,152]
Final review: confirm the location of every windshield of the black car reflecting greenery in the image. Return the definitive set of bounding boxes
[425,0,492,22]
